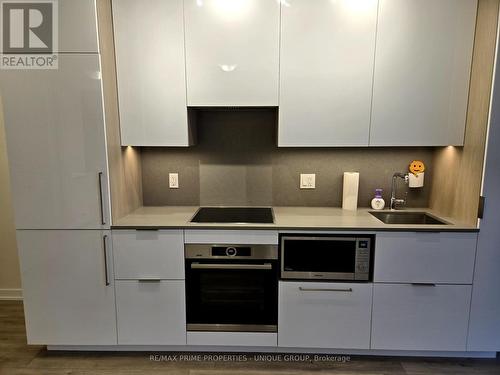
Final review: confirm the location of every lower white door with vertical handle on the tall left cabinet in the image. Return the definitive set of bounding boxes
[17,230,117,345]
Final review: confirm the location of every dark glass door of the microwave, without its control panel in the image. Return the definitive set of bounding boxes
[280,236,362,280]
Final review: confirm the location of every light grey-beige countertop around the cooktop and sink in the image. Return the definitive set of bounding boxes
[112,206,478,232]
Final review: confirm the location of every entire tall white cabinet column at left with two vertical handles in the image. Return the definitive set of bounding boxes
[0,0,116,345]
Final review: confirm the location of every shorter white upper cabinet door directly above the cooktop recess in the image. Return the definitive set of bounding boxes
[186,0,280,106]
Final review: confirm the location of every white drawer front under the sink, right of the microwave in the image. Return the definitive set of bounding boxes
[374,232,477,284]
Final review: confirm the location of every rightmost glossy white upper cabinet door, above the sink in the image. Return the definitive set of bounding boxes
[370,0,477,146]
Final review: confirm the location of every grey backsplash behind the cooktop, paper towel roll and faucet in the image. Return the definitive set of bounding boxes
[142,110,433,207]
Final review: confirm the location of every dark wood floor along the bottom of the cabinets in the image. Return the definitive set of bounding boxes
[0,301,500,375]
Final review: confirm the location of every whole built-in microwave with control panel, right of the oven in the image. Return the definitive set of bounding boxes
[280,234,375,281]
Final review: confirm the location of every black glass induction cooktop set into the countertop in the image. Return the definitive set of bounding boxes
[191,207,274,224]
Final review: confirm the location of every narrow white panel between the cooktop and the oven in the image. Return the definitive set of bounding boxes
[185,229,278,245]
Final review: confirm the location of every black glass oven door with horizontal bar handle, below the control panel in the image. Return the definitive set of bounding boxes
[186,259,278,332]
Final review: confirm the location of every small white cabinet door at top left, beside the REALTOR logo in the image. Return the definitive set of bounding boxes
[58,0,98,53]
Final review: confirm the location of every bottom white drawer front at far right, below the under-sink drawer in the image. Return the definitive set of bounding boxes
[371,284,472,351]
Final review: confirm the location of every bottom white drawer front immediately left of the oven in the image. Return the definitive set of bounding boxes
[116,280,186,345]
